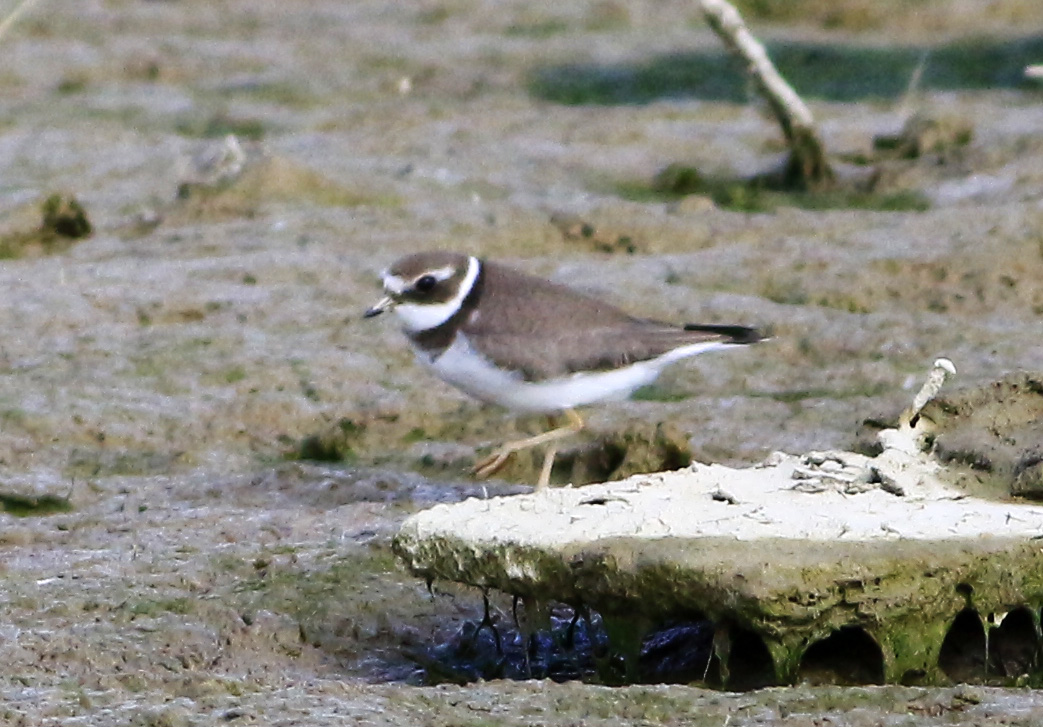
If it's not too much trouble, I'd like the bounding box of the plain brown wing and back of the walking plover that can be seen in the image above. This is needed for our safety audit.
[461,263,749,381]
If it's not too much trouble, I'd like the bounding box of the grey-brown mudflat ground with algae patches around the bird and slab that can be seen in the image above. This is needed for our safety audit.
[0,0,1043,725]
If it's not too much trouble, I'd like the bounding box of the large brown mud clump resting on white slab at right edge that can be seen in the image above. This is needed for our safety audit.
[920,372,1043,500]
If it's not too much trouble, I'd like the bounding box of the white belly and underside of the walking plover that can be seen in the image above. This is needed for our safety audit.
[418,336,727,413]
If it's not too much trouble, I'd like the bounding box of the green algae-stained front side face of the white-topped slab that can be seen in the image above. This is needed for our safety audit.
[395,527,1043,683]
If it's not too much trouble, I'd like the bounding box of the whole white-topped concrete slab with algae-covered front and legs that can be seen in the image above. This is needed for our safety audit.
[394,428,1043,684]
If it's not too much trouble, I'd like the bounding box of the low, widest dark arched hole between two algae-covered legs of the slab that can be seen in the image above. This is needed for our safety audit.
[798,626,883,685]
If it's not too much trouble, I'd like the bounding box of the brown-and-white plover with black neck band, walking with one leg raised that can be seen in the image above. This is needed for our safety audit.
[365,251,761,488]
